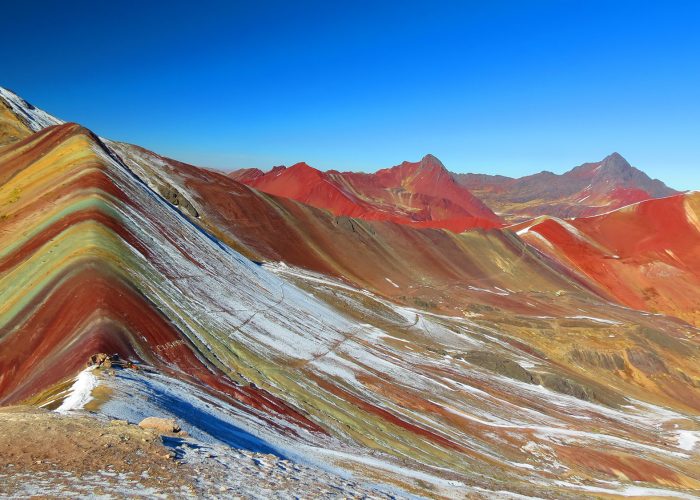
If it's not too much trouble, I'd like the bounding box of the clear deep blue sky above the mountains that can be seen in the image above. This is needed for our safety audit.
[0,0,700,189]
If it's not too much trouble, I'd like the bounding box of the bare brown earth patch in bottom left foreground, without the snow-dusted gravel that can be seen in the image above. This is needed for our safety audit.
[0,406,194,496]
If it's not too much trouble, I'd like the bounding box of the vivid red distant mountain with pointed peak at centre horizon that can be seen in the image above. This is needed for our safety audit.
[230,155,501,232]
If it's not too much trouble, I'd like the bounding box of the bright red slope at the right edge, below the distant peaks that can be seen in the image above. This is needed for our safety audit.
[513,193,700,324]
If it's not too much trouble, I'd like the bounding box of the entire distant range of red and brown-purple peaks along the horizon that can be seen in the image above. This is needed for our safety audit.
[229,153,678,228]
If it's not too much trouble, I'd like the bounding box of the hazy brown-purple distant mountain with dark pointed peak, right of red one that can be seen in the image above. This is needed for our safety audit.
[454,153,678,222]
